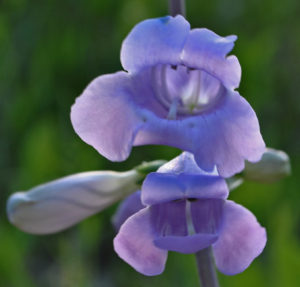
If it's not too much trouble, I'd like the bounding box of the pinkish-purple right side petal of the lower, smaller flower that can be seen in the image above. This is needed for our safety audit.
[213,201,267,275]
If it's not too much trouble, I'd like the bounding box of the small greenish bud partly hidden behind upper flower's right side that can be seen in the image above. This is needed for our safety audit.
[244,148,291,183]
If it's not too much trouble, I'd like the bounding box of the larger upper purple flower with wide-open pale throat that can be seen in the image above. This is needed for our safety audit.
[71,16,265,177]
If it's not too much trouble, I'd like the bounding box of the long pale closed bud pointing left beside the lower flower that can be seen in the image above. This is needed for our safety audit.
[7,170,141,234]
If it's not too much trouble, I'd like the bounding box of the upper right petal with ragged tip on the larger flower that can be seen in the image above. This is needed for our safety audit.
[182,29,241,89]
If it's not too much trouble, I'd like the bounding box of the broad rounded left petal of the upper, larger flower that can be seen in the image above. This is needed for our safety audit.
[71,72,142,161]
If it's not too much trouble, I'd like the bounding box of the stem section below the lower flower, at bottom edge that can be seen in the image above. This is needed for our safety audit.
[195,247,219,287]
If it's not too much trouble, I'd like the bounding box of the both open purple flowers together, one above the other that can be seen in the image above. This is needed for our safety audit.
[71,16,266,275]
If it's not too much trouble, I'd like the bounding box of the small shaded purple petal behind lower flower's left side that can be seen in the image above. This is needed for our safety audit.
[112,190,145,231]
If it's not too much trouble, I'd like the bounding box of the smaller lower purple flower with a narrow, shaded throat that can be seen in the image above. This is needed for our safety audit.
[114,153,266,275]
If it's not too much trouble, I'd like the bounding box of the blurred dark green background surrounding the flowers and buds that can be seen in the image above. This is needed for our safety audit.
[0,0,300,287]
